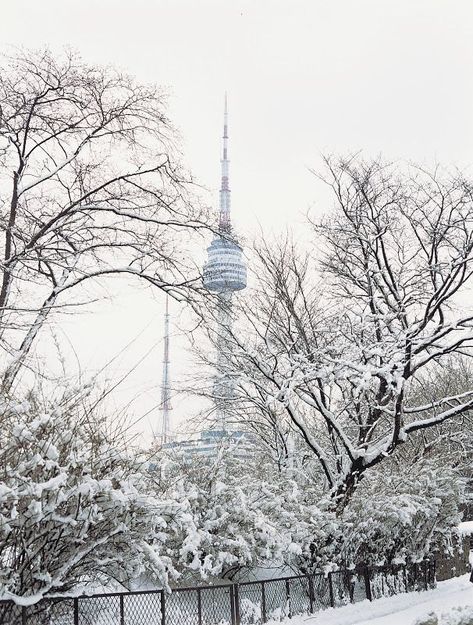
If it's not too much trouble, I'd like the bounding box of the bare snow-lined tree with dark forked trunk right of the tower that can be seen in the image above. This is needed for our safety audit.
[216,159,473,508]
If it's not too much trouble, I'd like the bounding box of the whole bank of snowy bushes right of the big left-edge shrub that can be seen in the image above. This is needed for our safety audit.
[148,442,465,579]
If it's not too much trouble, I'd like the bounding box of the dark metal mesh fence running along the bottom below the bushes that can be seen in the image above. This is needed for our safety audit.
[0,561,435,625]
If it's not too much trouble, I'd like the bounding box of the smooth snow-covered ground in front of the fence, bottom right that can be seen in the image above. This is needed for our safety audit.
[272,575,473,625]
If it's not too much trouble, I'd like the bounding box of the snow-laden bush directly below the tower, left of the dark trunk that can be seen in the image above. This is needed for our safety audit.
[149,450,308,579]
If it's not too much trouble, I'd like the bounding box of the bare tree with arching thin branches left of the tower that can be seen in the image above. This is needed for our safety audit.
[0,51,203,389]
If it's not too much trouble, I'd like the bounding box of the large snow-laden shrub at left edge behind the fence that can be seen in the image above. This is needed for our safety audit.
[0,390,178,601]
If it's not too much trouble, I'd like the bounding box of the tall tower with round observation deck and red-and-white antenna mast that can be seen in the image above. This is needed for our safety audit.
[203,94,246,432]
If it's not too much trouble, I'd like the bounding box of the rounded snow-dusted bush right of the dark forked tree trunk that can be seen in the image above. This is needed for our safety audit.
[340,461,465,565]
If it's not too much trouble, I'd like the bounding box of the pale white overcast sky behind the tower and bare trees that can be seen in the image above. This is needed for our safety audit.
[0,0,473,436]
